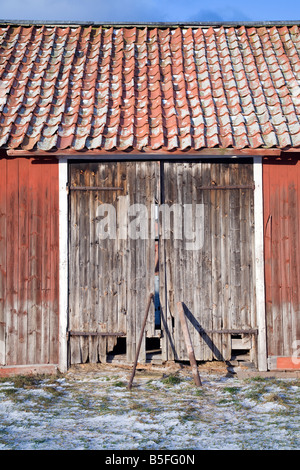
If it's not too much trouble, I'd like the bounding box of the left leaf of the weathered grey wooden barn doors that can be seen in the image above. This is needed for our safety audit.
[69,162,159,364]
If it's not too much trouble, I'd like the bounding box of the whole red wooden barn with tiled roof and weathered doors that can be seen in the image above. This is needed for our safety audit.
[0,21,300,375]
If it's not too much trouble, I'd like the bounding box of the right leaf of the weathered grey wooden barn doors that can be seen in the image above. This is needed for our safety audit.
[160,161,256,360]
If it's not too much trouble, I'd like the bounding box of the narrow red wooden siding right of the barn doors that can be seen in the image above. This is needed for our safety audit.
[263,155,300,368]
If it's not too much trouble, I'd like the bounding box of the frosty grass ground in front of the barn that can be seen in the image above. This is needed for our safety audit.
[0,366,300,450]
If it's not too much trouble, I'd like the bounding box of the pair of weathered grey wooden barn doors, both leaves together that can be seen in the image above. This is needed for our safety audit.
[69,160,256,363]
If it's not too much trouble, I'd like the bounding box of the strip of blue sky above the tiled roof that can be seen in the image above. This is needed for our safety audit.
[0,0,300,23]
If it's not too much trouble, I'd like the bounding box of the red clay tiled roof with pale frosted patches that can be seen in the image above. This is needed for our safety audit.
[0,25,300,151]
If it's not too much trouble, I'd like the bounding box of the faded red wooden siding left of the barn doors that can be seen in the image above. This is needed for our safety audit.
[0,158,59,366]
